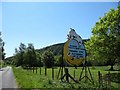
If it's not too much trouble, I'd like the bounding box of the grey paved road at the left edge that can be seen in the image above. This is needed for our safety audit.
[0,66,17,90]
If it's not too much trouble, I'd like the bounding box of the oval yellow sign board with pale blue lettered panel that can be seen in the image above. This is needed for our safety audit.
[64,28,85,66]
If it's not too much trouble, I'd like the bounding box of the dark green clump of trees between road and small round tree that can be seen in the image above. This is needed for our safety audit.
[14,43,37,67]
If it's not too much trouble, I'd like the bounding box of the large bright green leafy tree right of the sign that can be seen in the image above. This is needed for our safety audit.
[85,6,120,70]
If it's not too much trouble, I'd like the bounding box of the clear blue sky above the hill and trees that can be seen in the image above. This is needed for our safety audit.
[0,2,118,57]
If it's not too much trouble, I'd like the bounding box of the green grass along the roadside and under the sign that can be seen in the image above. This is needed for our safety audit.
[13,66,118,89]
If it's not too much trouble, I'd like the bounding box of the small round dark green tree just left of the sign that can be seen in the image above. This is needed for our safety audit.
[42,51,54,68]
